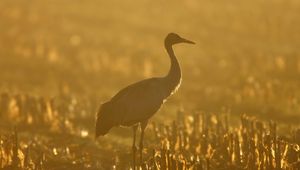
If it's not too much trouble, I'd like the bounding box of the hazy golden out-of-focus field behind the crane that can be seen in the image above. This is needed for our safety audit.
[0,0,300,169]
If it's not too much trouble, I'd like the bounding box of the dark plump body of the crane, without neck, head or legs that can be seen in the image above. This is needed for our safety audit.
[97,77,180,134]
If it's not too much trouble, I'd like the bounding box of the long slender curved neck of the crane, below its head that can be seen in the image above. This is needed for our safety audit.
[165,42,181,92]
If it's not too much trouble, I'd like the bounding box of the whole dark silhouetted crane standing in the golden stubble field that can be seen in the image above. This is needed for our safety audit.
[95,33,195,167]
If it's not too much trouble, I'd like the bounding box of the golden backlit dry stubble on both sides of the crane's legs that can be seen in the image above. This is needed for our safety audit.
[0,94,300,170]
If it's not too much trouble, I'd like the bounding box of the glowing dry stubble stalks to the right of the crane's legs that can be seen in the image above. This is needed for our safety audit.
[143,113,300,169]
